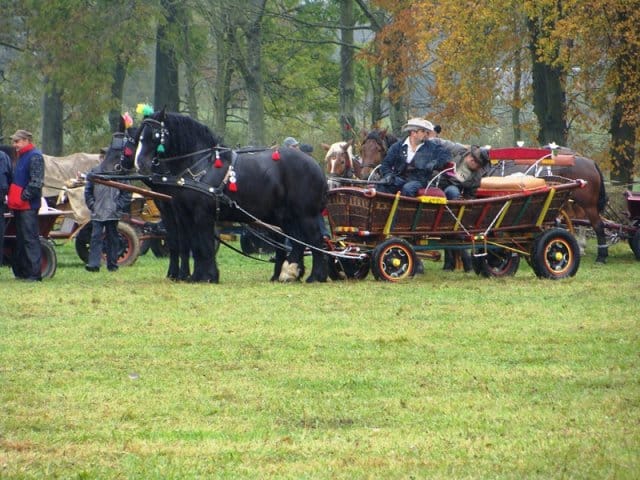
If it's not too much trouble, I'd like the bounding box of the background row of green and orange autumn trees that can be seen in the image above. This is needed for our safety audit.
[0,0,640,183]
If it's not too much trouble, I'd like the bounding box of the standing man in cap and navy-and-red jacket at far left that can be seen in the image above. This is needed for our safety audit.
[7,130,44,281]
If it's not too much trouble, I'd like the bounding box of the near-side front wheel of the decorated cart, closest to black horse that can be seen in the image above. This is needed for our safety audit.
[371,238,417,282]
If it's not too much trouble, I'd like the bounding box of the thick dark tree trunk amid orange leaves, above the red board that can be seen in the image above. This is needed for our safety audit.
[527,15,567,145]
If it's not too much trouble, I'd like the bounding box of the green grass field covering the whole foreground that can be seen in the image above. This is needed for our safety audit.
[0,239,640,479]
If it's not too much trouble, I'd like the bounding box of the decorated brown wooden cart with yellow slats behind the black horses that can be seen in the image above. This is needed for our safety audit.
[327,177,584,281]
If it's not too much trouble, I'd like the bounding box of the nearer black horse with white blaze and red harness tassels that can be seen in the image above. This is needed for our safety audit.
[127,110,327,283]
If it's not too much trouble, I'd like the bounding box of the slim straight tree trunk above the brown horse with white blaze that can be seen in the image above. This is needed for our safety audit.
[340,0,356,140]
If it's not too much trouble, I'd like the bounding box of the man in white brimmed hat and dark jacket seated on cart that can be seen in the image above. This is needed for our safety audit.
[378,118,450,197]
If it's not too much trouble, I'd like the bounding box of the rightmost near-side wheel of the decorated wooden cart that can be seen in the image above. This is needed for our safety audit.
[531,228,580,280]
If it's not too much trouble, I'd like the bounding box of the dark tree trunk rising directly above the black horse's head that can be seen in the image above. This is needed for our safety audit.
[153,0,180,112]
